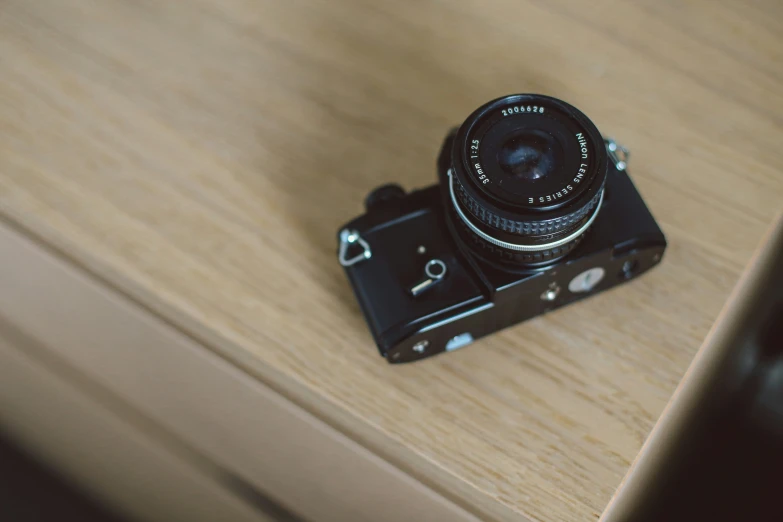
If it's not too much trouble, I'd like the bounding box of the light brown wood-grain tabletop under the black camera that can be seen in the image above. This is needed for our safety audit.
[0,0,783,521]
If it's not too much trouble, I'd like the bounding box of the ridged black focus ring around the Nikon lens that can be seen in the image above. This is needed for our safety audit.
[454,179,601,236]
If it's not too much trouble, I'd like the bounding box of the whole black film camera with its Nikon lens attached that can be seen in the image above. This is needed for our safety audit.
[338,94,666,363]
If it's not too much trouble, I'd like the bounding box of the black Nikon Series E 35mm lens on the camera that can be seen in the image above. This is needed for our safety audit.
[448,94,607,266]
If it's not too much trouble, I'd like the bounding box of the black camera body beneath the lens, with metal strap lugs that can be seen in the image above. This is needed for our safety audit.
[338,94,666,363]
